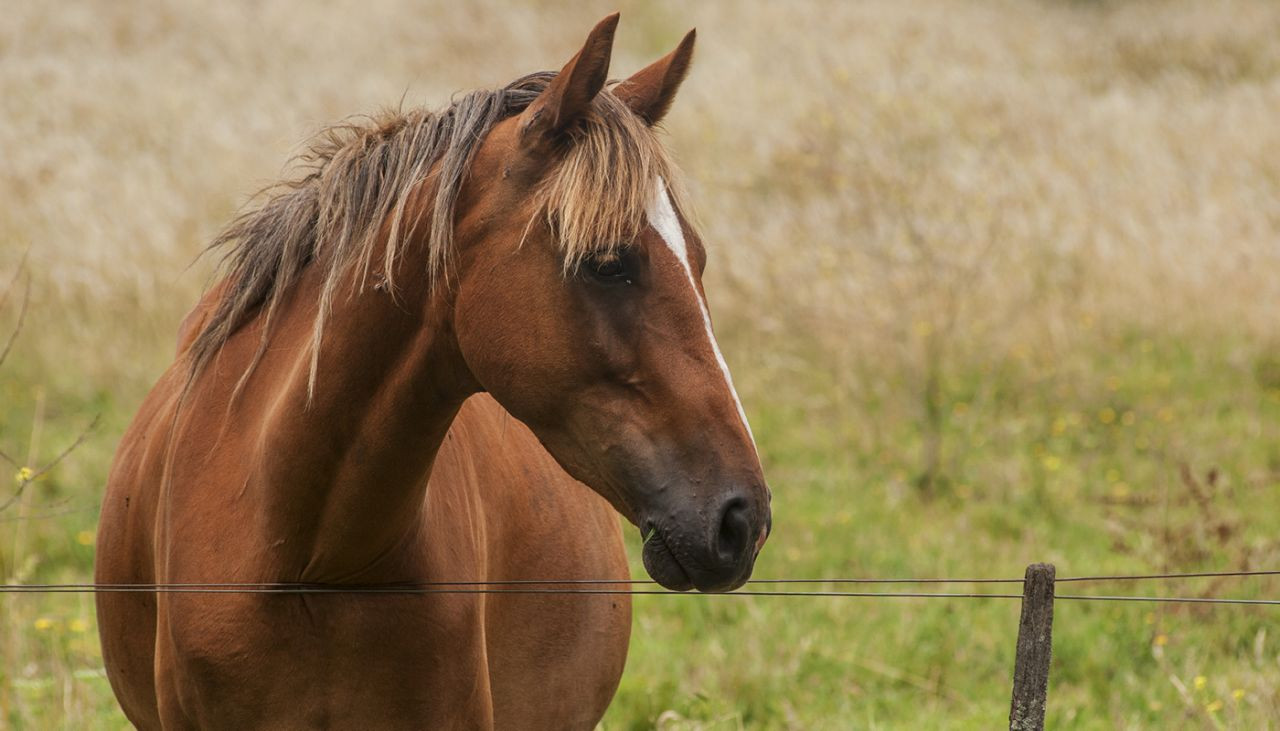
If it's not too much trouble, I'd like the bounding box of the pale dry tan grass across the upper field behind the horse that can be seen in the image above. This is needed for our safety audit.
[0,1,1280,412]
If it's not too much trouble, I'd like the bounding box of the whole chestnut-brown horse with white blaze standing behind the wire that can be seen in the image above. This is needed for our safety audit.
[96,15,769,728]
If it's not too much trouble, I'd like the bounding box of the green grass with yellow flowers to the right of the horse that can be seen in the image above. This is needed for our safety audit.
[605,327,1280,728]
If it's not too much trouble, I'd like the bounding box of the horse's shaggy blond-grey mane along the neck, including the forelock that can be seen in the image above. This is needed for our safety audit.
[187,72,682,388]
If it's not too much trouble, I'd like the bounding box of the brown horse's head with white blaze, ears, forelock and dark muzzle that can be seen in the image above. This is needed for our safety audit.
[449,15,771,591]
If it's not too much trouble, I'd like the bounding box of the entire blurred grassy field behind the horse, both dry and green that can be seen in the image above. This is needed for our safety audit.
[0,0,1280,728]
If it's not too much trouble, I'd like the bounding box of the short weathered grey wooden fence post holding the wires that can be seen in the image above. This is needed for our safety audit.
[1009,563,1055,731]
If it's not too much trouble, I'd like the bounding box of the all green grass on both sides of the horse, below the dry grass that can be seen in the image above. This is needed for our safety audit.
[0,322,1280,728]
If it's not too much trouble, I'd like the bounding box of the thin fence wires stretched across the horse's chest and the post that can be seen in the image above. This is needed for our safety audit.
[0,570,1280,606]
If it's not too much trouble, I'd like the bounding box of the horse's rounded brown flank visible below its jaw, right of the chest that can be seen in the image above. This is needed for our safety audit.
[426,394,631,728]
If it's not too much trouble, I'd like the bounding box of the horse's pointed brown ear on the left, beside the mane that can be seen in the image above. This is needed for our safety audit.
[520,13,618,145]
